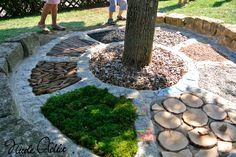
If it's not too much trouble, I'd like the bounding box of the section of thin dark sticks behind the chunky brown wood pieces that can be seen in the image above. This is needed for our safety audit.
[47,36,96,57]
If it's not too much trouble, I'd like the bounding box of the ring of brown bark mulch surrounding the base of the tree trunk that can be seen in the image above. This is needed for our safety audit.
[90,45,187,90]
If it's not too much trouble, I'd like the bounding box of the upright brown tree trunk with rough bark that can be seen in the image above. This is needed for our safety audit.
[122,0,158,68]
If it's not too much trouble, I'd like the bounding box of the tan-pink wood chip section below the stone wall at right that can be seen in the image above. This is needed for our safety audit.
[181,42,228,62]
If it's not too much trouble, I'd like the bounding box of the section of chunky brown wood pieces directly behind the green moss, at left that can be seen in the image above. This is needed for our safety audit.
[29,61,81,95]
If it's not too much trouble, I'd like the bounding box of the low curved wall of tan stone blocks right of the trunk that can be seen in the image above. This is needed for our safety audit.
[156,13,236,53]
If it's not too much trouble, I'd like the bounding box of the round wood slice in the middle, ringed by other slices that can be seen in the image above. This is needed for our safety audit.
[183,109,208,127]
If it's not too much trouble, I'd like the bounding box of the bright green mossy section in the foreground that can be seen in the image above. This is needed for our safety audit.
[42,86,137,157]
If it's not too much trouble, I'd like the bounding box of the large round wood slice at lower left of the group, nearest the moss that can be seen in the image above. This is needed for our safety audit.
[157,131,188,151]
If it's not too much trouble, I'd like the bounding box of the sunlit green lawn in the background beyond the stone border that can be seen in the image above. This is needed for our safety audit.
[0,0,236,42]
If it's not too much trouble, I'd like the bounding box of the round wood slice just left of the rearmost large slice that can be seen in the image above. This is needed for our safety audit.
[163,98,186,114]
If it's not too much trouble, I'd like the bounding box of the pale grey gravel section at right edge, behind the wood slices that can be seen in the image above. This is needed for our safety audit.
[198,64,236,102]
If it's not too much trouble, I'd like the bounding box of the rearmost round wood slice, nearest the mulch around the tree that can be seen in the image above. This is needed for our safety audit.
[180,93,204,108]
